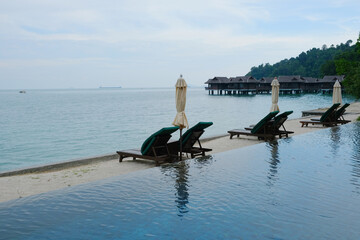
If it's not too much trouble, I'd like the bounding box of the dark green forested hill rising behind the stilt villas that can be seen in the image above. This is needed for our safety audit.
[246,34,360,97]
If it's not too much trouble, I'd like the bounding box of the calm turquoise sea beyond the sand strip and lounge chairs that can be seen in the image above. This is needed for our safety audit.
[0,88,353,172]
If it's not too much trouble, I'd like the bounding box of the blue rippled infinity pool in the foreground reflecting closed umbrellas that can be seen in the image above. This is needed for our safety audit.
[0,123,360,239]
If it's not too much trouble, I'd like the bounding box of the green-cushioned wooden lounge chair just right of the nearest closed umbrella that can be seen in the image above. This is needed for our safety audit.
[169,122,213,158]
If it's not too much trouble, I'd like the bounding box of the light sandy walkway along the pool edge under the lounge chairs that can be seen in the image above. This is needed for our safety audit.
[0,102,360,202]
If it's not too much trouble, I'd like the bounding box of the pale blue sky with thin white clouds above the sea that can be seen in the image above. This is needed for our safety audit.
[0,0,360,89]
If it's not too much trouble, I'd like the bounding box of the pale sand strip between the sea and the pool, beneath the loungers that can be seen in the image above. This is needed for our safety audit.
[0,102,360,202]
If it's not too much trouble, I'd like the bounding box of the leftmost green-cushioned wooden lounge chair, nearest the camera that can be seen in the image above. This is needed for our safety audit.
[117,127,179,165]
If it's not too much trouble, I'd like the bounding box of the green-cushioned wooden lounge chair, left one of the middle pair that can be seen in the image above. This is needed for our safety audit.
[228,111,279,140]
